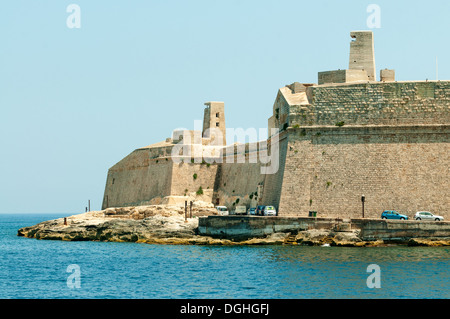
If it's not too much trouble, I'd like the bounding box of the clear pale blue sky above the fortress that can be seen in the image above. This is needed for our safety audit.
[0,0,450,214]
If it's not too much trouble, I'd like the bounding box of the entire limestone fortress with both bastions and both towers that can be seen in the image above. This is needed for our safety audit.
[102,31,450,219]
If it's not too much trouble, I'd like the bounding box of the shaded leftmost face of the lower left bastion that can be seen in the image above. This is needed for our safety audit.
[102,149,172,209]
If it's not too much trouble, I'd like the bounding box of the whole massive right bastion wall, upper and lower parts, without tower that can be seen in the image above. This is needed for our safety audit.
[263,81,450,218]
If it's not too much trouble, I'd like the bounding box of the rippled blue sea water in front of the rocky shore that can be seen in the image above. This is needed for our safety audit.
[0,214,450,299]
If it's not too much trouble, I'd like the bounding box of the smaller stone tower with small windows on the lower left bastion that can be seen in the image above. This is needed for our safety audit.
[203,102,226,145]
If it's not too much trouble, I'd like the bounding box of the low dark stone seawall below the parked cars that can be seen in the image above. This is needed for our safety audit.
[198,216,450,242]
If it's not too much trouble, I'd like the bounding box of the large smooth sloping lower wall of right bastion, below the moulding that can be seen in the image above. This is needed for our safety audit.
[280,125,450,219]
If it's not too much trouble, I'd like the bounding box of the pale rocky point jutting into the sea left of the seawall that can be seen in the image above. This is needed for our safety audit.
[18,205,216,242]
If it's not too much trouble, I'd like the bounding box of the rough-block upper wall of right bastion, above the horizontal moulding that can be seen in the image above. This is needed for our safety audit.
[289,81,450,127]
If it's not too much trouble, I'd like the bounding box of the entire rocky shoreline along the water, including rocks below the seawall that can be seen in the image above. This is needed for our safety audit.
[18,203,450,247]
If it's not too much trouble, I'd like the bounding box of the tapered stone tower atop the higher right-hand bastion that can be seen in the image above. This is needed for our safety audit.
[349,31,376,81]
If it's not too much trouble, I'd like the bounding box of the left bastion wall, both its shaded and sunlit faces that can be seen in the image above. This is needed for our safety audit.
[102,146,218,209]
